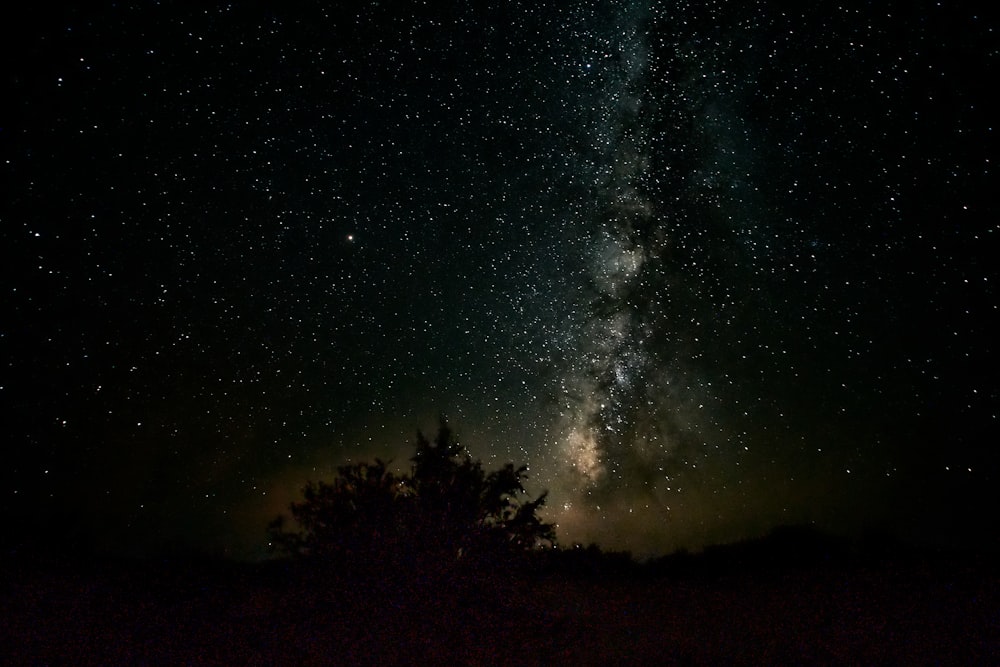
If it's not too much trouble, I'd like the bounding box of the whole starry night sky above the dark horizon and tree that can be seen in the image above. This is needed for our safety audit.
[0,0,1000,557]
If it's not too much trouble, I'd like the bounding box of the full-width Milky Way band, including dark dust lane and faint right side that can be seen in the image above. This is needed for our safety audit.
[559,6,754,544]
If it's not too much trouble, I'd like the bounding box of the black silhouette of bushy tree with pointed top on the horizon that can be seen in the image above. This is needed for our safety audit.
[270,418,555,562]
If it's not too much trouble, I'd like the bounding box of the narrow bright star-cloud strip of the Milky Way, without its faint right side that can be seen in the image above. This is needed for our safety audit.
[560,1,670,506]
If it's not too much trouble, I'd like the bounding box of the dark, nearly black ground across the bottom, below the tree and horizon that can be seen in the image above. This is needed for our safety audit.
[0,544,1000,665]
